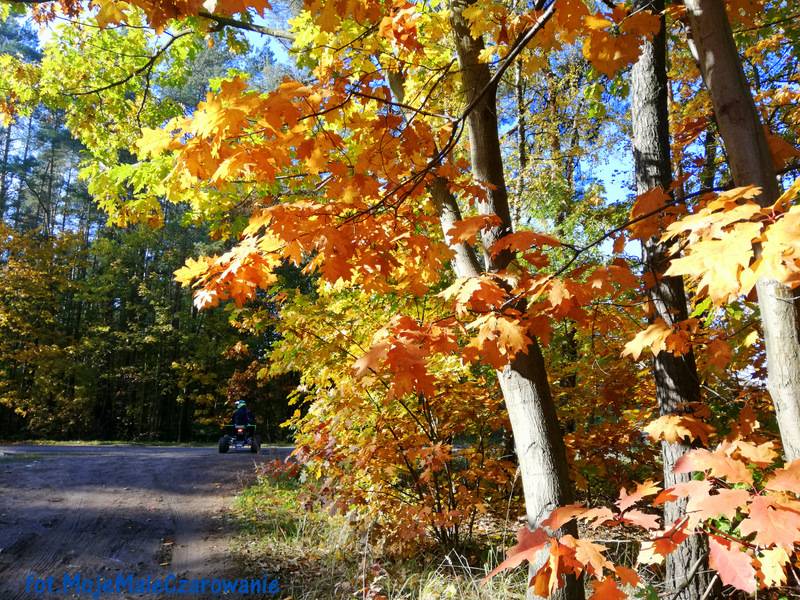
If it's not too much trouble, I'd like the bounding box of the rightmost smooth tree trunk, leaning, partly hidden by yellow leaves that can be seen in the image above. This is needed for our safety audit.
[685,0,800,460]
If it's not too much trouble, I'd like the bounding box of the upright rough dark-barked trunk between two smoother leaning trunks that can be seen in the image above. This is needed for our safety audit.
[631,0,711,600]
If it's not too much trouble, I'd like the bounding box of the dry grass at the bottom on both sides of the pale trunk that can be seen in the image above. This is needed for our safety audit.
[228,461,663,600]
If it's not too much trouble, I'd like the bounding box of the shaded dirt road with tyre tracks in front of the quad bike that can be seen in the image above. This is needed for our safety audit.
[0,446,289,600]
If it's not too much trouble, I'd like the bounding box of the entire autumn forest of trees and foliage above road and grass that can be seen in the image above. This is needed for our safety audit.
[0,0,800,600]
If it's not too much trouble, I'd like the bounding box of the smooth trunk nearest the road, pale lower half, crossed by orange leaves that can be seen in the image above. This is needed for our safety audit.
[450,0,583,600]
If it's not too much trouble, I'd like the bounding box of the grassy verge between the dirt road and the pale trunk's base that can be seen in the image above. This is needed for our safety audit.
[233,477,526,600]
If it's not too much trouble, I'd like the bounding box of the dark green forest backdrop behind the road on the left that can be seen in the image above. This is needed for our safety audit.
[0,20,296,441]
